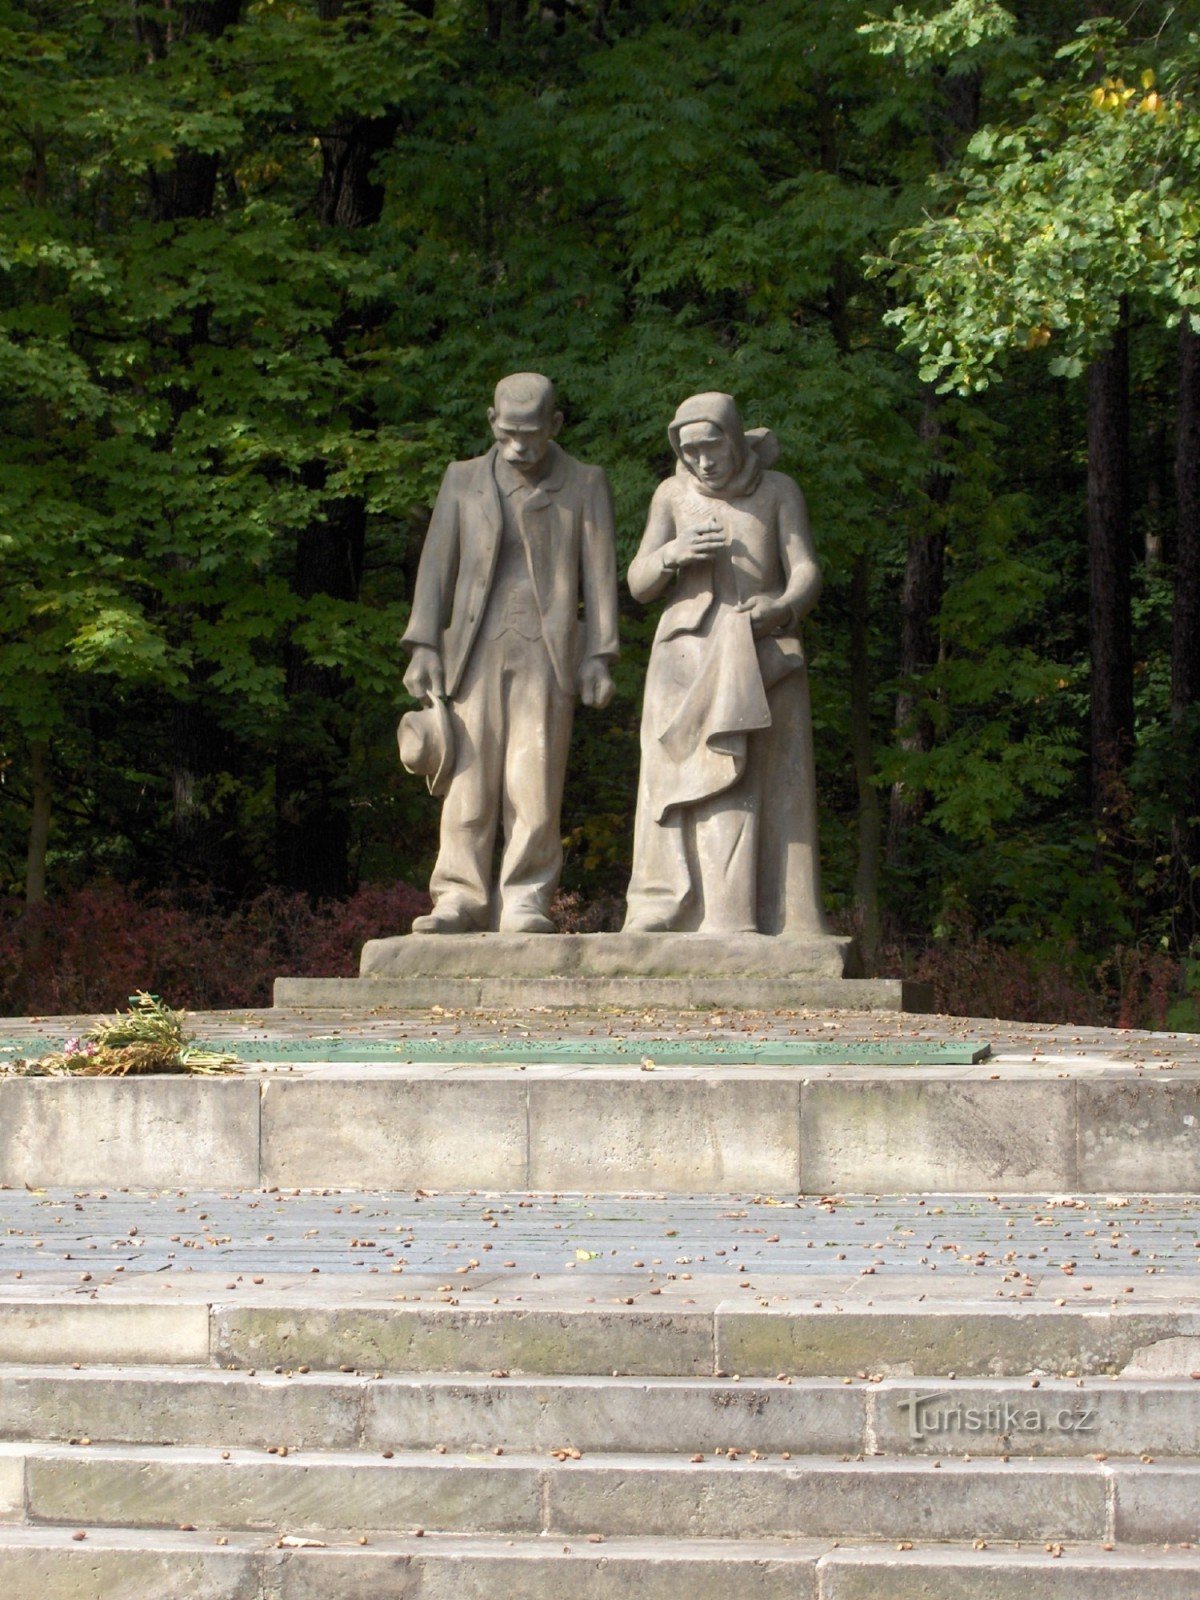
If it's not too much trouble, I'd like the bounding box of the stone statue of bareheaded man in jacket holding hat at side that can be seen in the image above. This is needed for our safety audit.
[402,373,618,933]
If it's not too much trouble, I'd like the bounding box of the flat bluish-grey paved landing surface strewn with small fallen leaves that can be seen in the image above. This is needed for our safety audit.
[0,1189,1200,1298]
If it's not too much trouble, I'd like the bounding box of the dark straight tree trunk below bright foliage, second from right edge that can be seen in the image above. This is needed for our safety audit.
[1088,318,1133,846]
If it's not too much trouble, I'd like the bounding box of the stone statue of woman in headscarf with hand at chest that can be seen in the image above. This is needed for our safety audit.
[626,394,829,938]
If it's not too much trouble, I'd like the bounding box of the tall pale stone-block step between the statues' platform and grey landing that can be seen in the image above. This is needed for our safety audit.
[0,1045,1200,1197]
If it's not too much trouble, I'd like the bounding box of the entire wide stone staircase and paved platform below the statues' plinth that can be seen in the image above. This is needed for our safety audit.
[0,1013,1200,1600]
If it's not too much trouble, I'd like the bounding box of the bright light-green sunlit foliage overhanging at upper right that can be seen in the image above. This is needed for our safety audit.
[866,0,1200,394]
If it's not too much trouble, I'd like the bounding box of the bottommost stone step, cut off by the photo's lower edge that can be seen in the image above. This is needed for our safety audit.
[0,1526,1200,1600]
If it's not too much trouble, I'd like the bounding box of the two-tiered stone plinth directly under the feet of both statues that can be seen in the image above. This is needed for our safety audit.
[275,933,933,1011]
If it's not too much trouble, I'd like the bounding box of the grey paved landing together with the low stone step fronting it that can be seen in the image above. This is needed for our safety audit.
[0,1190,1200,1376]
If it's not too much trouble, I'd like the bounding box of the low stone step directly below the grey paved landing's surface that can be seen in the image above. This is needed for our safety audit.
[0,1275,1200,1378]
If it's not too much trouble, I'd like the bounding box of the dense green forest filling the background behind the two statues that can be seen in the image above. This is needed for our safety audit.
[0,0,1200,1026]
